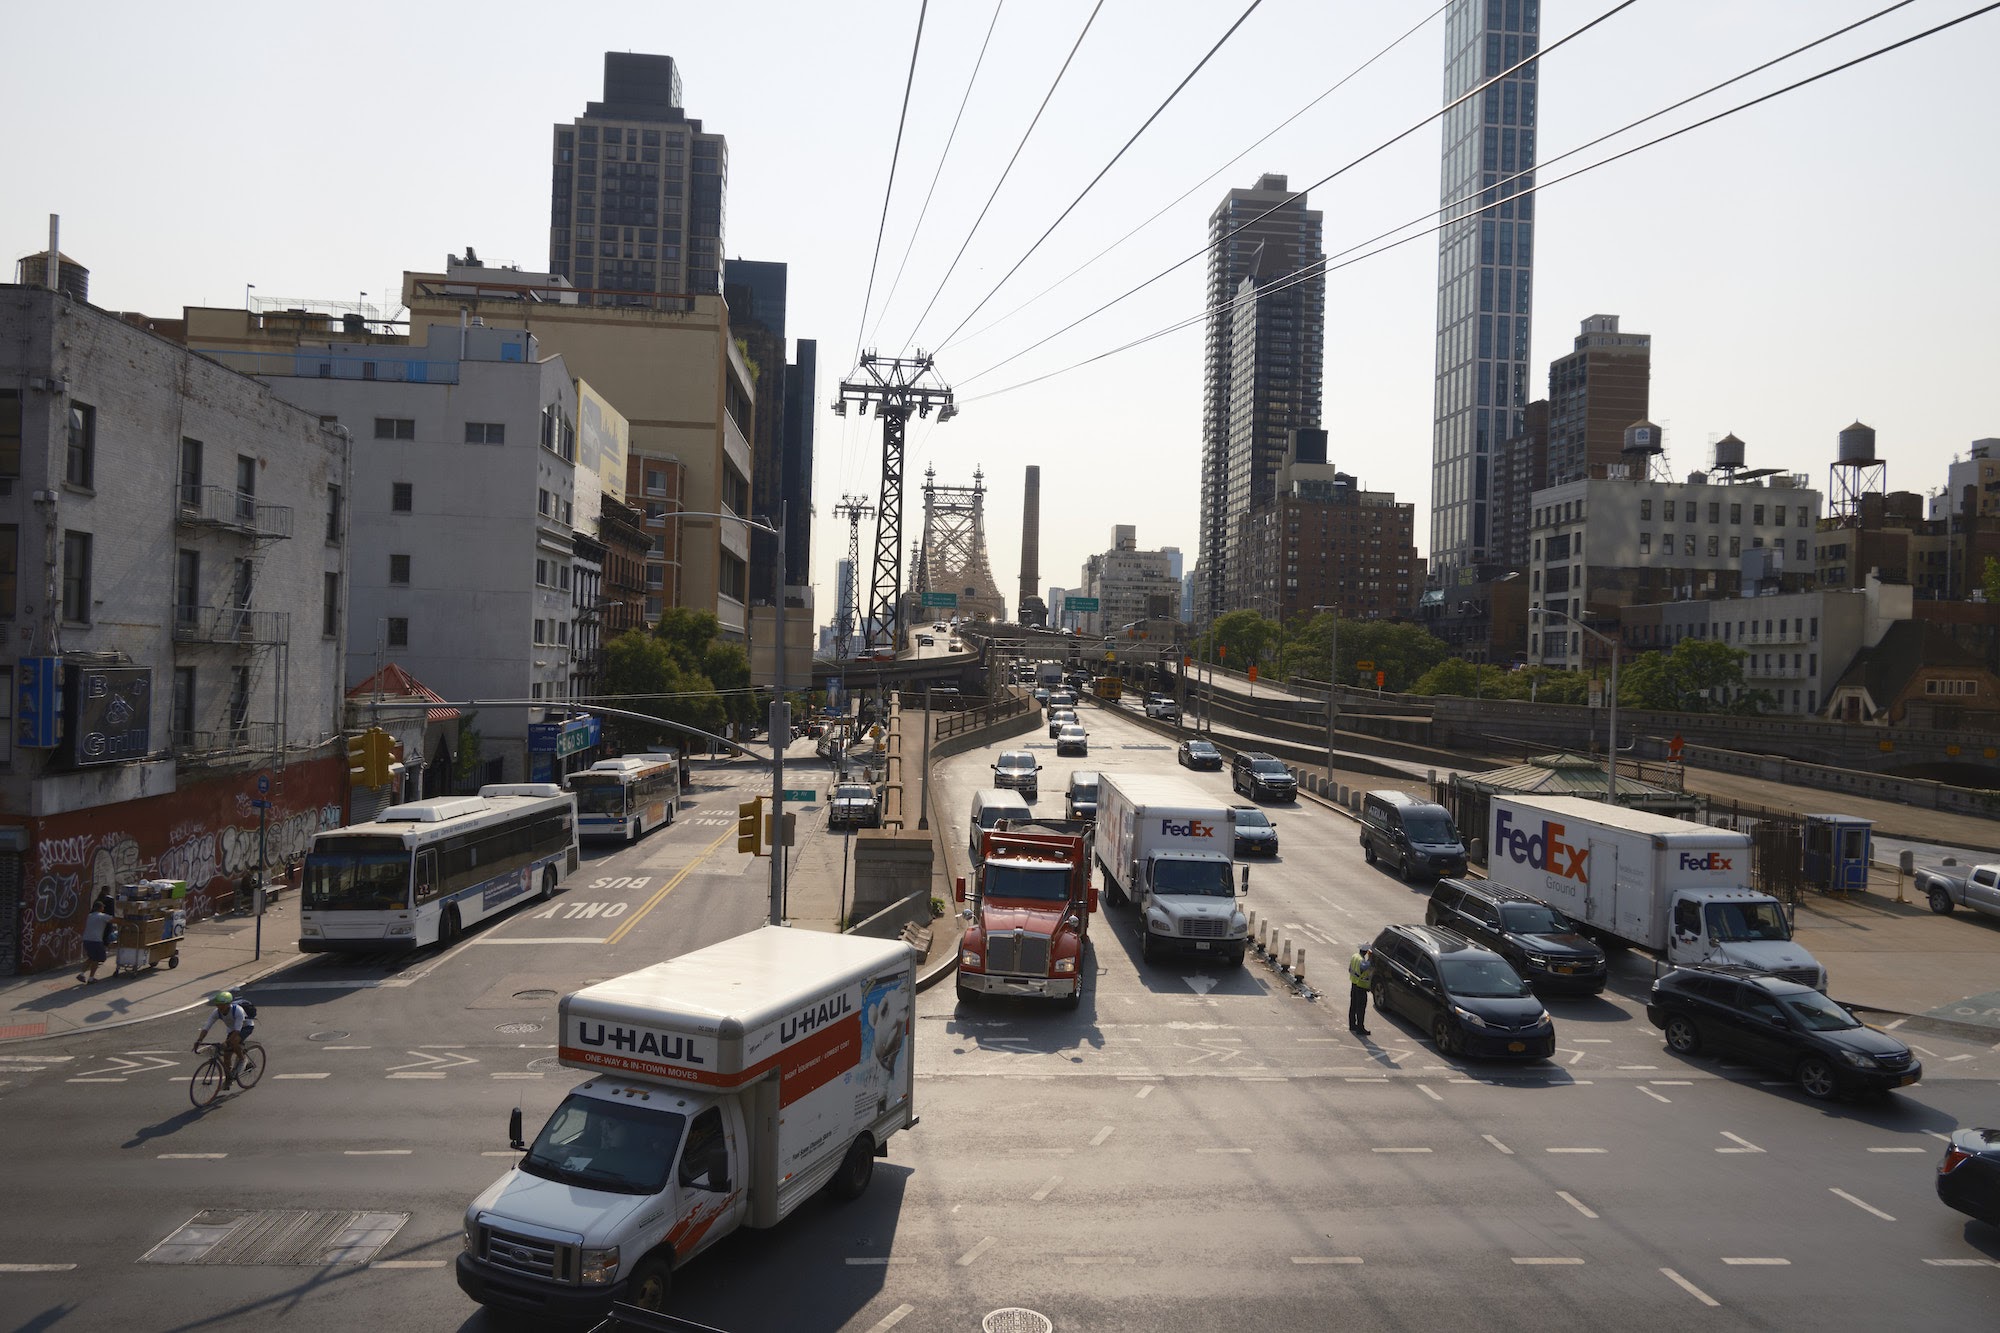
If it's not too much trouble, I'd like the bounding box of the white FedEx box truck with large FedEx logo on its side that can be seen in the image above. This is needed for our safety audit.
[1486,795,1826,991]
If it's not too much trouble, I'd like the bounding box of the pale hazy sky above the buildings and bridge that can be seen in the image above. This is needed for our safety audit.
[0,0,2000,620]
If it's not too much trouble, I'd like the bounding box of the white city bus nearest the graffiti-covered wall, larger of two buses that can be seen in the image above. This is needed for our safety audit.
[298,783,578,953]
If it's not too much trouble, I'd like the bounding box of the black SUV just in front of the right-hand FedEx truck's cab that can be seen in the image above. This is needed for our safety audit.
[1646,967,1924,1099]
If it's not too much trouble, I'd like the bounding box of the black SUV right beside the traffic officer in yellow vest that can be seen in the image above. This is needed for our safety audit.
[1372,925,1556,1061]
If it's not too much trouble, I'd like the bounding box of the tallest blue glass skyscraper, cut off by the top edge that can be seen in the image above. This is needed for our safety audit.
[1430,0,1542,584]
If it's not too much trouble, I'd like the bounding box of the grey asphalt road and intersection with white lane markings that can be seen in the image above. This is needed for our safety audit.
[0,709,2000,1333]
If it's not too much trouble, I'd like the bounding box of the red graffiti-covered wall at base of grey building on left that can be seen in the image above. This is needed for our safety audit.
[16,757,348,973]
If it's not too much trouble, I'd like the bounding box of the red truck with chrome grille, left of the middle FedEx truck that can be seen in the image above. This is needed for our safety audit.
[958,827,1098,1009]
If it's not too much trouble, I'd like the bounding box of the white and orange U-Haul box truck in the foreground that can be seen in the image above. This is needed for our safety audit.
[458,927,916,1319]
